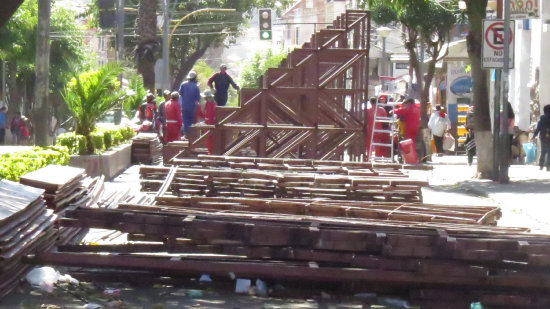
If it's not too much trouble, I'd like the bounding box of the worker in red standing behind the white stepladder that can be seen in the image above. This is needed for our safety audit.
[366,97,391,160]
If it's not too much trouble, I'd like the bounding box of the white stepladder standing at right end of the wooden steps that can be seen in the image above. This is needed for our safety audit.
[368,100,397,162]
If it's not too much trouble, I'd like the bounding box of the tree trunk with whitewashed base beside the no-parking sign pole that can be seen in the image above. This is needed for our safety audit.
[466,0,493,179]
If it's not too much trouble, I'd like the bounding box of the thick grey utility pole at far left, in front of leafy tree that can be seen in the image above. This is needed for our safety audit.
[32,0,51,146]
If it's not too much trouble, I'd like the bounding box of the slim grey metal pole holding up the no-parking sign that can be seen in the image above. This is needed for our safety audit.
[498,0,511,183]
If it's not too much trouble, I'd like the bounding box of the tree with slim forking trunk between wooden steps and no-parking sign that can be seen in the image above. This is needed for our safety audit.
[367,0,456,157]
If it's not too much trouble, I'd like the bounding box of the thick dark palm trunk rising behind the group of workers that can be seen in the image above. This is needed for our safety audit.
[134,0,160,93]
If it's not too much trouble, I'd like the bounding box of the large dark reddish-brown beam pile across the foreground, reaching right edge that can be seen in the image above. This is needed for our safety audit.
[37,205,550,308]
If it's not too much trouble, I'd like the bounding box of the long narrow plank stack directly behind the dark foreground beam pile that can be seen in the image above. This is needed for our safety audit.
[155,196,502,225]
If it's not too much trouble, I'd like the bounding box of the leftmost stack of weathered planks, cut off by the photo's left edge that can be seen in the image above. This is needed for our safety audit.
[0,180,56,297]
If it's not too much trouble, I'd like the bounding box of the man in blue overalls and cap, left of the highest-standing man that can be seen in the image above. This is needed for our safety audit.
[179,71,201,136]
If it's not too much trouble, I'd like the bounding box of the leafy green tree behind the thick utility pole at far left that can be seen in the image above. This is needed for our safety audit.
[0,0,94,139]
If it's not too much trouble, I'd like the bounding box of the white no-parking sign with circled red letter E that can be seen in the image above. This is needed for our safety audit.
[481,19,515,69]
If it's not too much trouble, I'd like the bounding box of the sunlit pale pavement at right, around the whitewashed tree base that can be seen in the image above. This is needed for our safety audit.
[410,155,550,234]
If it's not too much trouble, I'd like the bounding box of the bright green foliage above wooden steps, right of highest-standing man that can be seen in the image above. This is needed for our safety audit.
[239,49,288,88]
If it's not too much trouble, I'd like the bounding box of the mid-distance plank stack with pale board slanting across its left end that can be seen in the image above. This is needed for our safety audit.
[140,166,428,202]
